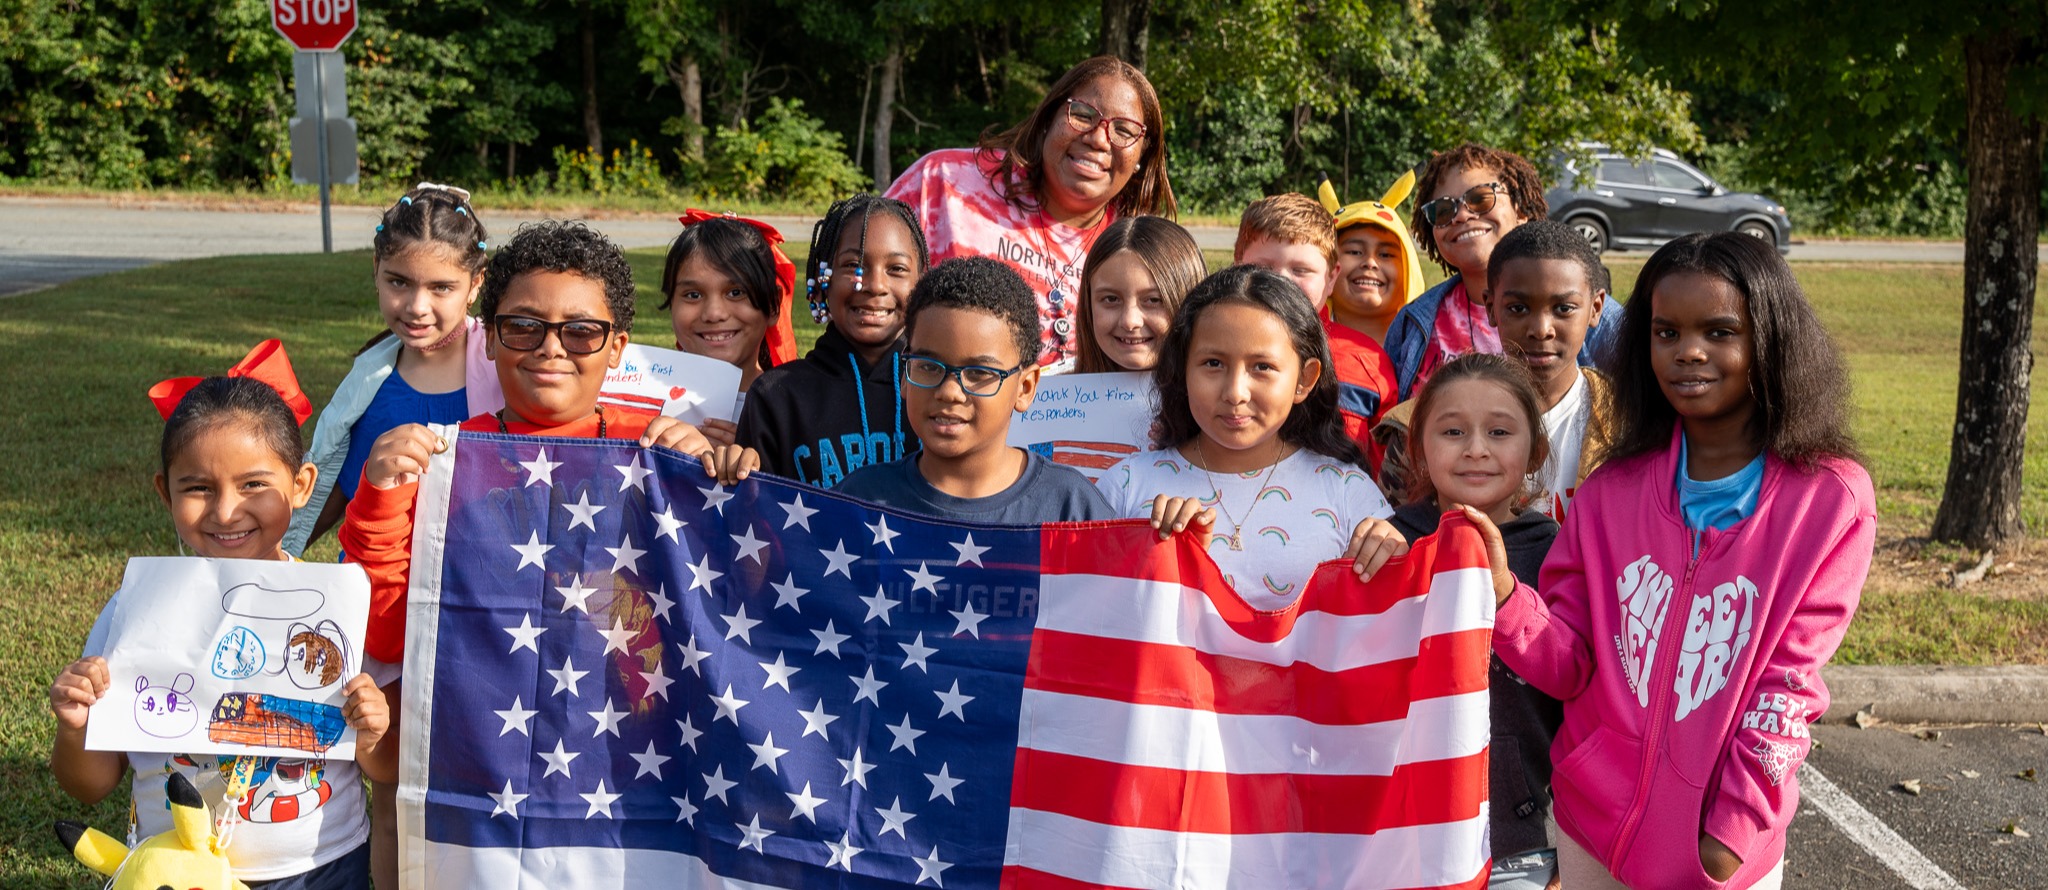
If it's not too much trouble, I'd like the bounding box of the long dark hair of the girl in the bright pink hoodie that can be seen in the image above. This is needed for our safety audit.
[1608,231,1860,469]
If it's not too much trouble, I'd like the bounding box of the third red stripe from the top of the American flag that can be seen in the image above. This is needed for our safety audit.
[1010,749,1487,835]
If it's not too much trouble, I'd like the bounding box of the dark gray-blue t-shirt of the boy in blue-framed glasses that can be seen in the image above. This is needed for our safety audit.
[831,450,1116,526]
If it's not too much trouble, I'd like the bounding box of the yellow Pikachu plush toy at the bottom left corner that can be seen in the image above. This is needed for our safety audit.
[57,773,248,890]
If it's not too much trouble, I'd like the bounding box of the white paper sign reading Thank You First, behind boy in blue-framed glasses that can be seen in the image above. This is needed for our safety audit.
[1010,370,1155,481]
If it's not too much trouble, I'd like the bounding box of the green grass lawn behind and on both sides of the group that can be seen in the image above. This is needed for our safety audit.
[0,246,2048,888]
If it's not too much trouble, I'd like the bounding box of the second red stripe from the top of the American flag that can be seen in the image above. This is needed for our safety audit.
[1024,628,1493,726]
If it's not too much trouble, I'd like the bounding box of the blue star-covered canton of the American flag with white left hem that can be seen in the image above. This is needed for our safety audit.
[406,434,1040,888]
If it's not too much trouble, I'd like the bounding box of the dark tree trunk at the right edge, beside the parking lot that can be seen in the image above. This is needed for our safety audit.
[1933,29,2042,548]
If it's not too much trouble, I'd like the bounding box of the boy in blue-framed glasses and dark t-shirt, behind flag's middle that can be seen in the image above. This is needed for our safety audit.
[834,258,1116,526]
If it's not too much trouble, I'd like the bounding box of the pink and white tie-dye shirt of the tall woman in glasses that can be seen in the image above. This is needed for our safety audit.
[887,149,1116,364]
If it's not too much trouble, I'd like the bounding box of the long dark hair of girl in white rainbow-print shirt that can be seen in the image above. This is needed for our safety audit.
[1153,264,1362,464]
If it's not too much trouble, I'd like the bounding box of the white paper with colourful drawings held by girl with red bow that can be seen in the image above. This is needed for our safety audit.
[86,557,371,759]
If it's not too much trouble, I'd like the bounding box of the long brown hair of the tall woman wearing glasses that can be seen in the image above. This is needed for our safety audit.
[981,55,1180,217]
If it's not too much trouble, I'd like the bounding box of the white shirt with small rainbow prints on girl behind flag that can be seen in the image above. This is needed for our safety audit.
[1096,448,1395,610]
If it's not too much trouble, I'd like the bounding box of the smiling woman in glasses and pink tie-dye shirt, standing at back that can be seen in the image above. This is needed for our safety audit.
[887,55,1176,364]
